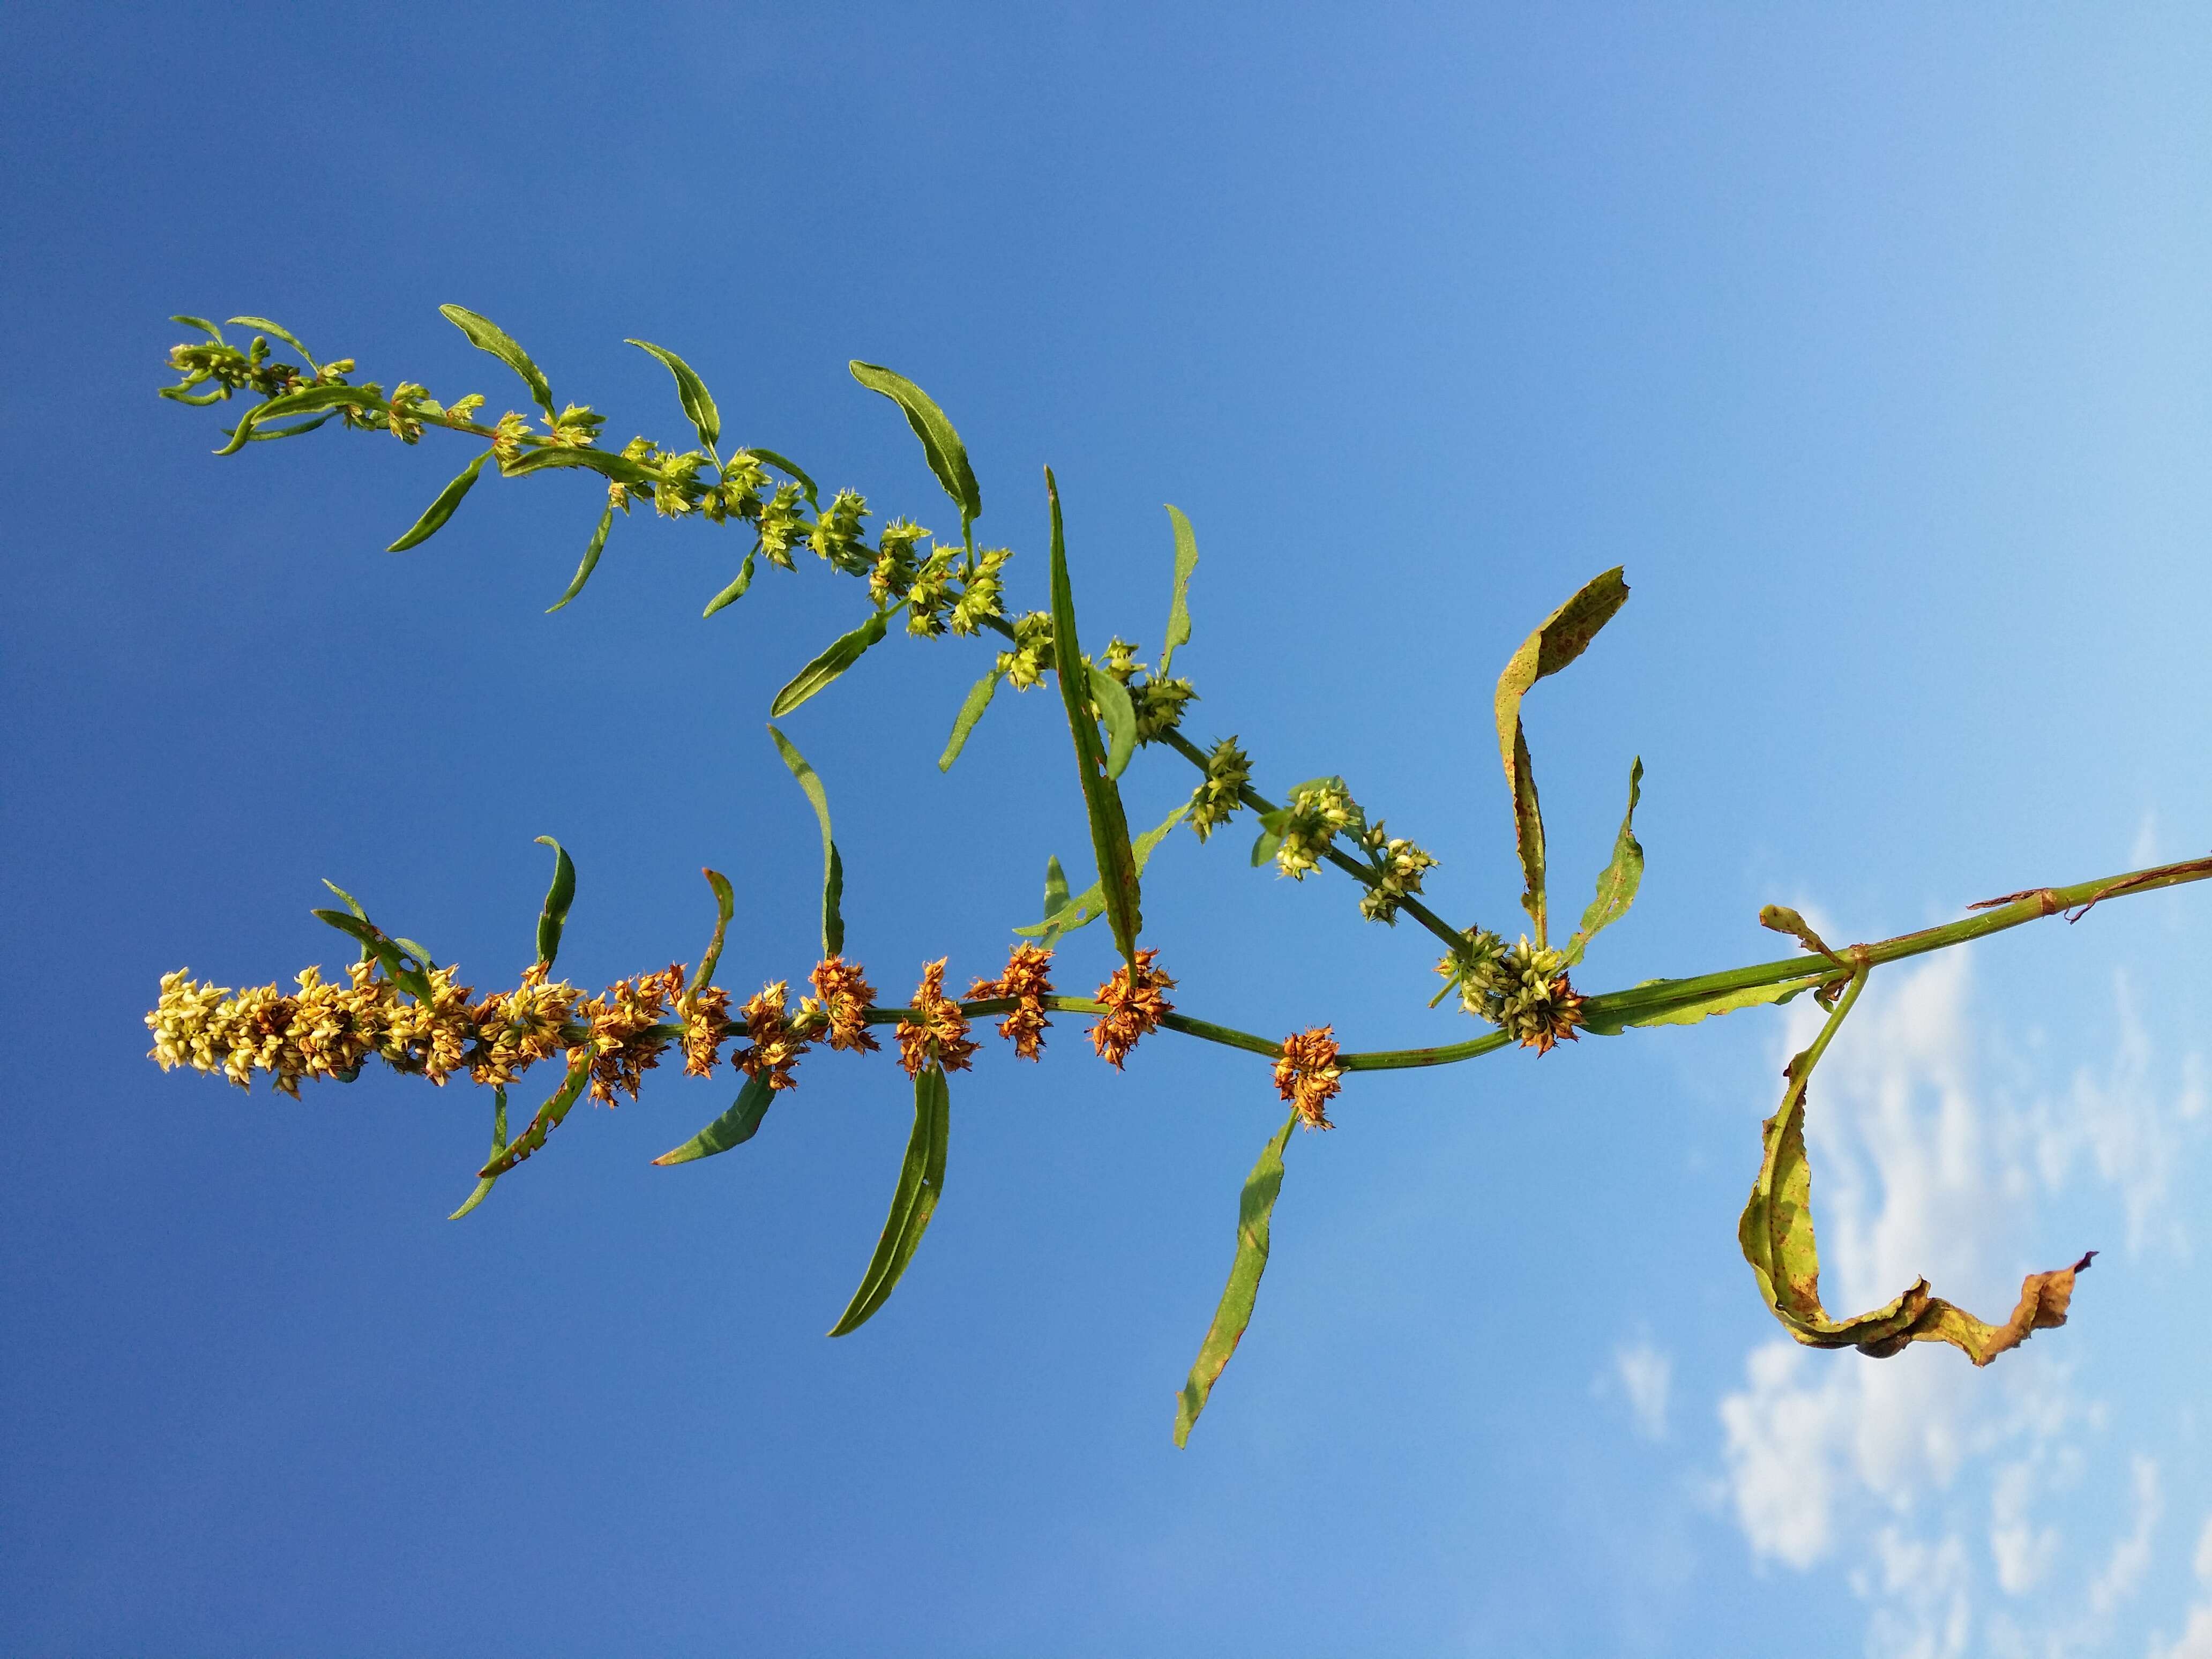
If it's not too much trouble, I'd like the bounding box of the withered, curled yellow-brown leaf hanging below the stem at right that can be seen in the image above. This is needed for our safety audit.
[1736,969,2097,1365]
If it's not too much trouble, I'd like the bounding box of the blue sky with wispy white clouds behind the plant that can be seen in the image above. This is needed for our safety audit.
[0,0,2212,1659]
